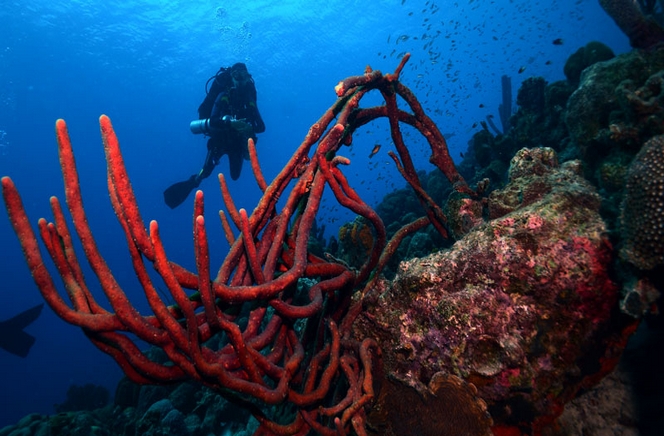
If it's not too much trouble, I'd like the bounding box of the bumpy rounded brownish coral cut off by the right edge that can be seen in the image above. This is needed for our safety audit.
[620,135,664,270]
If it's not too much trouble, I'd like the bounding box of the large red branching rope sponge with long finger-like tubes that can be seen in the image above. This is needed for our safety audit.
[2,55,477,436]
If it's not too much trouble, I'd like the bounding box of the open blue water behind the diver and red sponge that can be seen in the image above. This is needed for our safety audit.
[0,0,629,428]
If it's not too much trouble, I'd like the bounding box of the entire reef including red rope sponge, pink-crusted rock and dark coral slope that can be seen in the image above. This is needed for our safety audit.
[6,5,664,430]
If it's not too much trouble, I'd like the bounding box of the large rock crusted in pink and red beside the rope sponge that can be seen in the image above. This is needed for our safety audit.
[355,148,617,431]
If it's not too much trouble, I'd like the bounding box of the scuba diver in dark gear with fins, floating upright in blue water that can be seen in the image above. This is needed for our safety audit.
[164,63,265,209]
